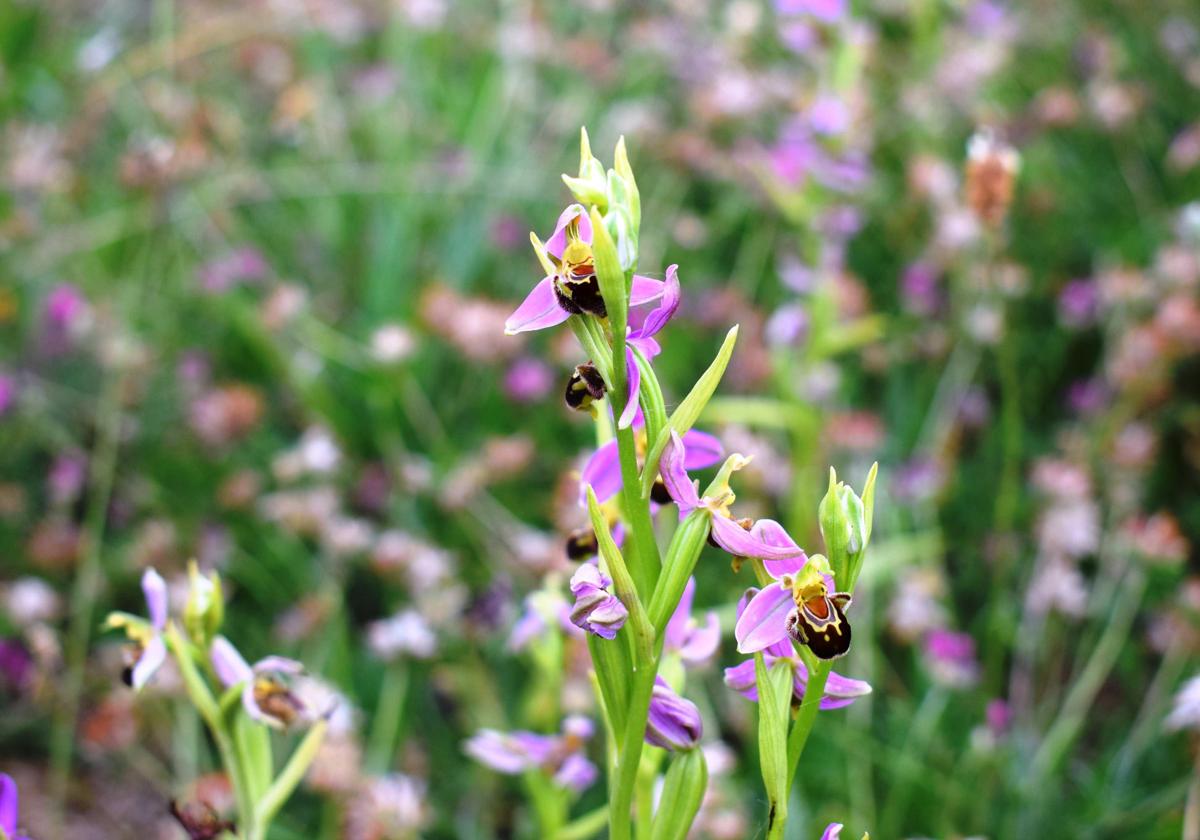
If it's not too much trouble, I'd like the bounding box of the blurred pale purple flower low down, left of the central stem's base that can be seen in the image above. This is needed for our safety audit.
[463,715,598,793]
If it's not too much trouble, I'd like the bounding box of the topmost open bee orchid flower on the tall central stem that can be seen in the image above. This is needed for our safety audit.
[504,204,665,335]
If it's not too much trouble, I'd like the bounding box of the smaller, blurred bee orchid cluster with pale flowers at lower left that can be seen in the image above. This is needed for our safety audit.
[103,562,332,840]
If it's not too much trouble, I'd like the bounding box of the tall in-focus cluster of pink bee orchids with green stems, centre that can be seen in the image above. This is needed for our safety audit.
[466,131,875,840]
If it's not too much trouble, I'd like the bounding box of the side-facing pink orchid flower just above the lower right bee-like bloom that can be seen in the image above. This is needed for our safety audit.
[661,430,806,565]
